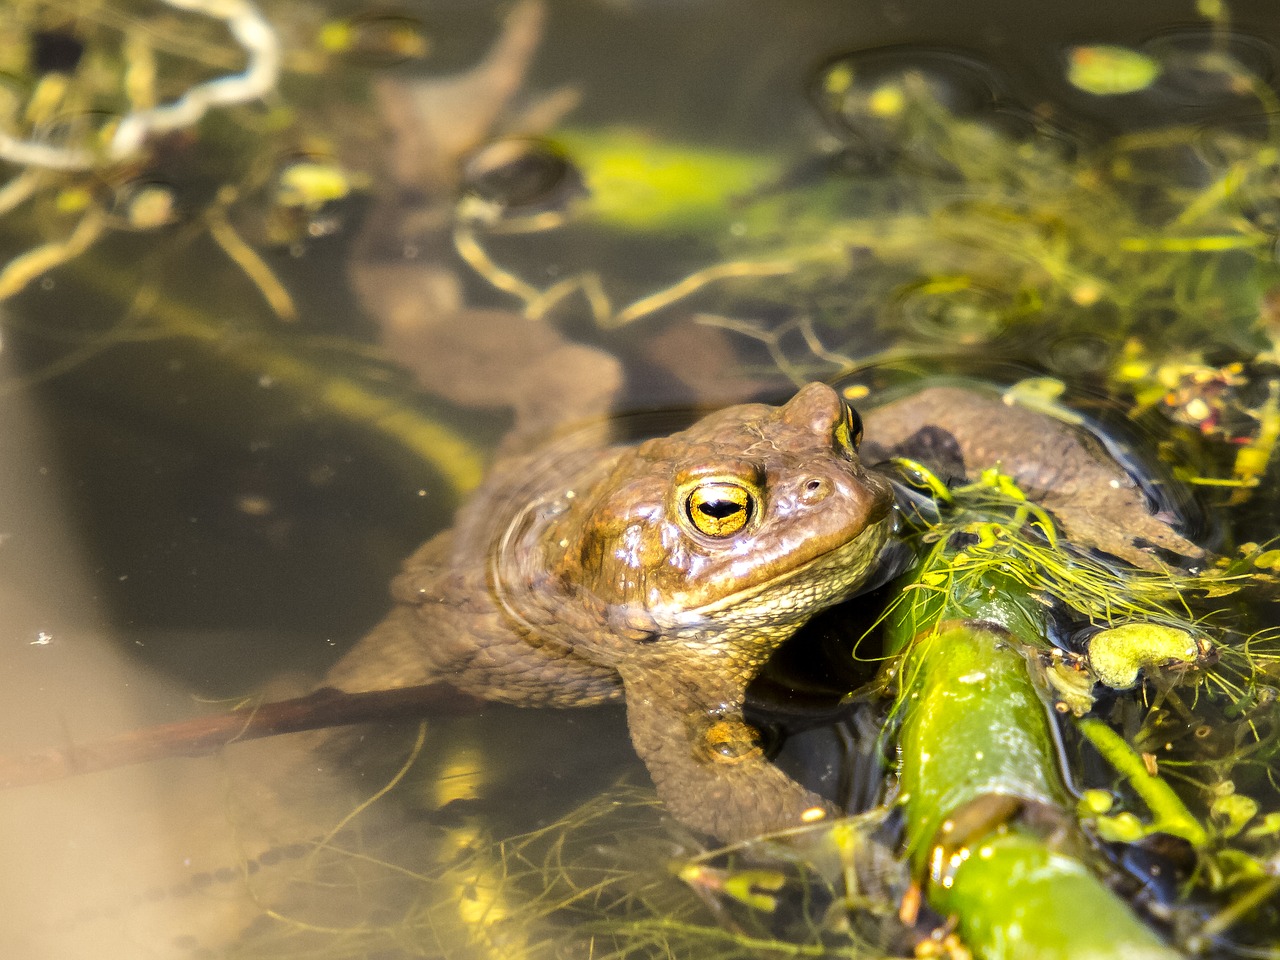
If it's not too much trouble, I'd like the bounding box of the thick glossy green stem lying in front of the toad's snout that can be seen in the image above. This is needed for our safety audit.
[887,570,1178,960]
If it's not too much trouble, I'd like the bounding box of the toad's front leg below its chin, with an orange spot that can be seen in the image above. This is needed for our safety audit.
[622,669,836,841]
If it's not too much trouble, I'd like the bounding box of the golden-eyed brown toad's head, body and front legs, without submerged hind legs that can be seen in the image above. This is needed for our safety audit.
[328,383,1198,840]
